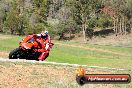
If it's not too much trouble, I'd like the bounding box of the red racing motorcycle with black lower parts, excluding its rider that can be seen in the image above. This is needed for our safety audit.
[9,35,54,60]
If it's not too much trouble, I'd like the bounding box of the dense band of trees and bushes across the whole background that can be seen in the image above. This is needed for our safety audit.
[0,0,132,38]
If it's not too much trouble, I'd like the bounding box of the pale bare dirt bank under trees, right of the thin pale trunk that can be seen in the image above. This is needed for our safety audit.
[88,35,132,46]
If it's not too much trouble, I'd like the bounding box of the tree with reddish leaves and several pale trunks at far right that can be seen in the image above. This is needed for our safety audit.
[103,0,132,35]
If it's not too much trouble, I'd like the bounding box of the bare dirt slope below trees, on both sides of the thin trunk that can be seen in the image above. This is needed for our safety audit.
[75,34,132,46]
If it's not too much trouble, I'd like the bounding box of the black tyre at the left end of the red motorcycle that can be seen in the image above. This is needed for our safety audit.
[9,48,21,59]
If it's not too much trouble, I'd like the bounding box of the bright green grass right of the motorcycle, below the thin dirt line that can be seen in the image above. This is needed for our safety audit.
[47,45,132,68]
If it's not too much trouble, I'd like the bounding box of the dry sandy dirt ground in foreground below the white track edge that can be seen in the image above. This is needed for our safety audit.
[0,62,118,88]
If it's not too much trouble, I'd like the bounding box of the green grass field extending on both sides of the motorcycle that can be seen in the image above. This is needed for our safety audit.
[0,35,132,69]
